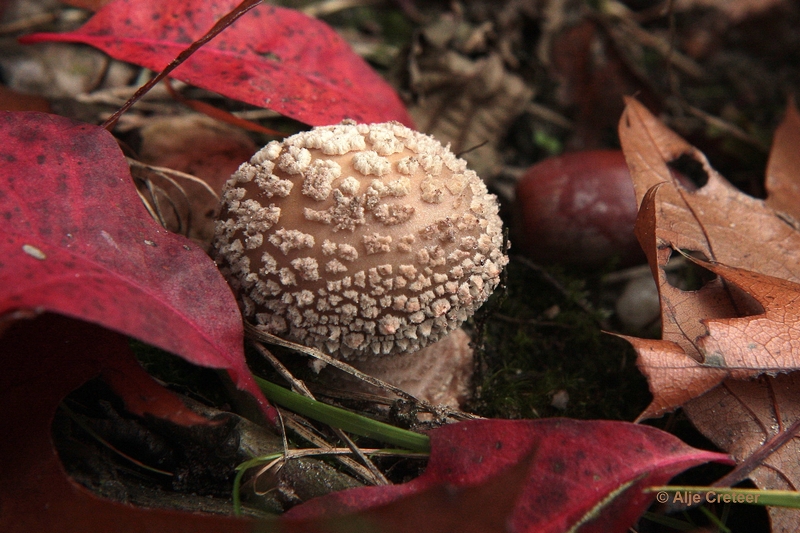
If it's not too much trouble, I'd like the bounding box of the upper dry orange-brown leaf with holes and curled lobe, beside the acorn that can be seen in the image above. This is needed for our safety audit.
[620,100,800,418]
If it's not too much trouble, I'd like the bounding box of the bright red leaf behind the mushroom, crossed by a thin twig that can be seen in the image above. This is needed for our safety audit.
[21,0,412,126]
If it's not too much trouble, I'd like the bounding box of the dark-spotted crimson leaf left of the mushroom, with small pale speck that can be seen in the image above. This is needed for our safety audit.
[0,112,273,424]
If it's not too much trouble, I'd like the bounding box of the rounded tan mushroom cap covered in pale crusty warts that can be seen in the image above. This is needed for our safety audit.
[208,121,508,359]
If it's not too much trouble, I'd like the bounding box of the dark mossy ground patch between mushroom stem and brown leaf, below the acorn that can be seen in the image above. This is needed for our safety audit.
[468,261,650,420]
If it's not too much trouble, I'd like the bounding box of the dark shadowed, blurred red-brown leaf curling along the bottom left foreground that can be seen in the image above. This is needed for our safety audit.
[0,314,524,533]
